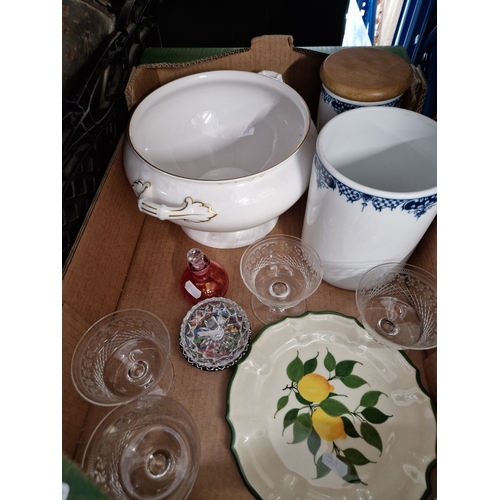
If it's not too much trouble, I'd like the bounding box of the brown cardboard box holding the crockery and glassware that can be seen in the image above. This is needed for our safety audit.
[62,36,437,500]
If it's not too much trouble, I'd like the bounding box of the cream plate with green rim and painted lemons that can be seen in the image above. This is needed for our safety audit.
[226,312,436,500]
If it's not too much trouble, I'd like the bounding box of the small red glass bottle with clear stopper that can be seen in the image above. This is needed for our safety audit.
[180,248,229,304]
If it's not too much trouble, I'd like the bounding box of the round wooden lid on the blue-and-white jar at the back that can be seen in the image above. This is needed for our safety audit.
[320,47,413,102]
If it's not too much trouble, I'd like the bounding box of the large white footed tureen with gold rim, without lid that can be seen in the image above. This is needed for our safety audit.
[123,71,317,248]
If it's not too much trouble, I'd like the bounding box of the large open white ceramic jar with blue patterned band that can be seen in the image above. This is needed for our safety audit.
[302,107,437,290]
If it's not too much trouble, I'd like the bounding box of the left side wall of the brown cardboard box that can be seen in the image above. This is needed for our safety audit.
[62,137,145,457]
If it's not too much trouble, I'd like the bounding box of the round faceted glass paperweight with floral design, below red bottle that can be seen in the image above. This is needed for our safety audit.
[179,297,252,371]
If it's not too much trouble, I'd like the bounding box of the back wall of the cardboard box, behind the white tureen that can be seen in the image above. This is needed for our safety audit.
[125,35,328,119]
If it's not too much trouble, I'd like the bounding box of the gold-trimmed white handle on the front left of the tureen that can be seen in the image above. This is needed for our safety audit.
[132,179,217,222]
